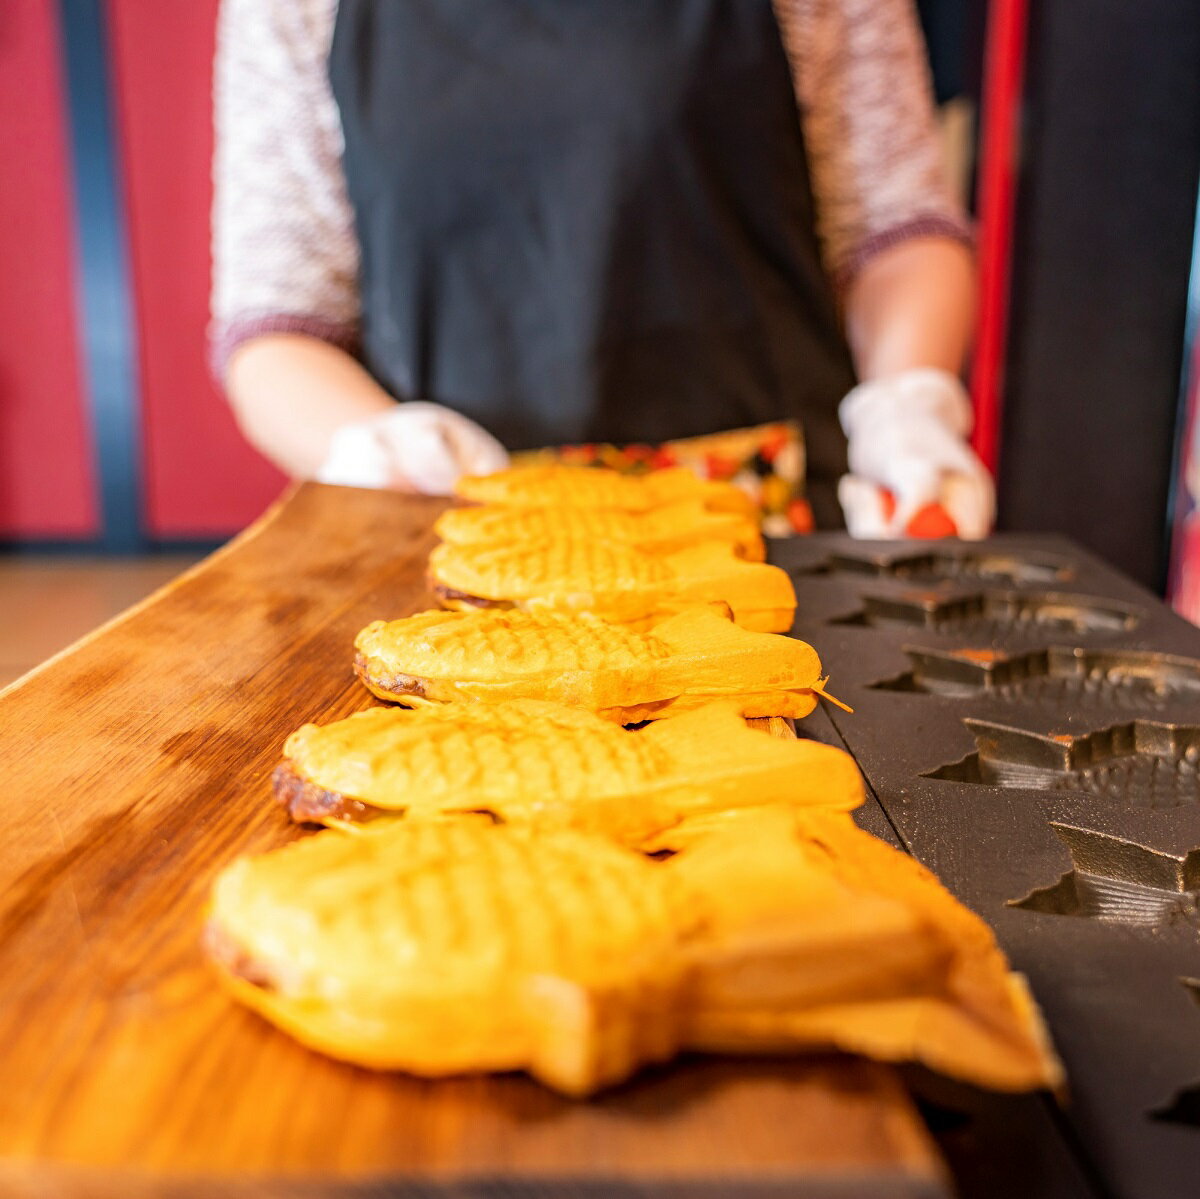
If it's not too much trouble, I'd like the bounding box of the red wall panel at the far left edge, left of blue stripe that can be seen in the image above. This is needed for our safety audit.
[0,0,97,538]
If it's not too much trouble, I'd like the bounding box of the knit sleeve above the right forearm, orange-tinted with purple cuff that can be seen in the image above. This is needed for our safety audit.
[775,0,972,289]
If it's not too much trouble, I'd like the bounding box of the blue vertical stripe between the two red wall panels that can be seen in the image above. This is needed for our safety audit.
[60,0,145,553]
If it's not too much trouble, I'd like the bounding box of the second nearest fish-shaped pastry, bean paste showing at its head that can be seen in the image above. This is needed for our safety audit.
[274,700,863,843]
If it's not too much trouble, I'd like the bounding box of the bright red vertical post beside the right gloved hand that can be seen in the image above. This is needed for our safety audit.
[971,0,1027,473]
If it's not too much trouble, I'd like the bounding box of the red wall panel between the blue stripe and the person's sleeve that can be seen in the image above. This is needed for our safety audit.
[107,0,283,538]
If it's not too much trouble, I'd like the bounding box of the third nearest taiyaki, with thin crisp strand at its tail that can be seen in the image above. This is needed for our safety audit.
[354,607,822,724]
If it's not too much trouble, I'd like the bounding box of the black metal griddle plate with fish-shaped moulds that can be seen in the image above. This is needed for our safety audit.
[770,534,1200,1199]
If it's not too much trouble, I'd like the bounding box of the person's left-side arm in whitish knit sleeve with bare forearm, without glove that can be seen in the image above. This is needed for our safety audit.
[210,0,364,478]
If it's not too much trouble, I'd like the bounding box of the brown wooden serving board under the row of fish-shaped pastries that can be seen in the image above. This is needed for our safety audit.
[0,485,946,1199]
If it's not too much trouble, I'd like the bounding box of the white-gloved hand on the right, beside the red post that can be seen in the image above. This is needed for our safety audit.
[838,368,996,540]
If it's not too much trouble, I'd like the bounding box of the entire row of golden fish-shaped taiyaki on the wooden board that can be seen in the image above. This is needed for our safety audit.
[206,467,1061,1095]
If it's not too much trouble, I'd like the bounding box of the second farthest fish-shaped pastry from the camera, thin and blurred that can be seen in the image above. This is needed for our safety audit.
[433,499,767,562]
